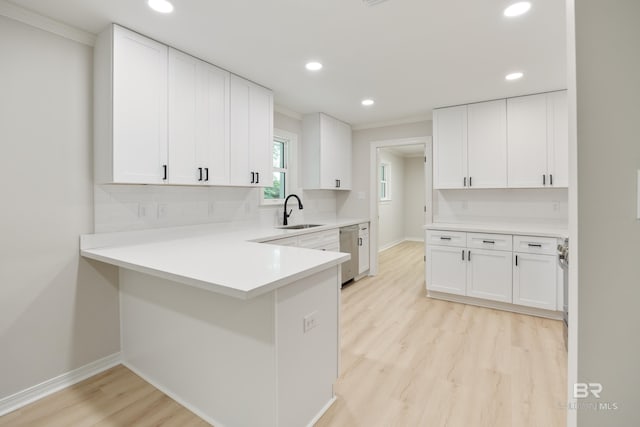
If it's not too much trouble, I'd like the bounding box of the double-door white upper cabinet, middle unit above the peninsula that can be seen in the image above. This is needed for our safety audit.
[169,49,229,185]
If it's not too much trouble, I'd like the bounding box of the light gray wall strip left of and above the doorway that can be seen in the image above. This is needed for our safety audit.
[336,120,432,218]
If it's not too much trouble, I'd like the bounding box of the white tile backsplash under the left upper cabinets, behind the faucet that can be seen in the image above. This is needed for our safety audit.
[94,185,336,233]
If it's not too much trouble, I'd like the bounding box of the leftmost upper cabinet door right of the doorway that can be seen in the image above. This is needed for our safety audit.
[433,105,467,189]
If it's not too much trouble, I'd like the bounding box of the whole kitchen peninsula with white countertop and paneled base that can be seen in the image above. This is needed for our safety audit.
[81,221,361,426]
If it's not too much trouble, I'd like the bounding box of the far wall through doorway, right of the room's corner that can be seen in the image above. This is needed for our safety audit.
[404,157,425,240]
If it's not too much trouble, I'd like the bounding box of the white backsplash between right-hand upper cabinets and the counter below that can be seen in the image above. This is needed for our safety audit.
[433,188,568,228]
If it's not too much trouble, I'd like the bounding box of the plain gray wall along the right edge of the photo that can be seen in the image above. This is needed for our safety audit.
[575,0,640,427]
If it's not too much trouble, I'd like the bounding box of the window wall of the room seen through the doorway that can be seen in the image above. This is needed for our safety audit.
[378,148,405,250]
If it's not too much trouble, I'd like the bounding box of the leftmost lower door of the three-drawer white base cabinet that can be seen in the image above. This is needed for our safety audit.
[425,245,467,295]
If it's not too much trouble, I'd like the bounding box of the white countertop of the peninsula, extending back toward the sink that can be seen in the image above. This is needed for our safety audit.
[80,219,368,299]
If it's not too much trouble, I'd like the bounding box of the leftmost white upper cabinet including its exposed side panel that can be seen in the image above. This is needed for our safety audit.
[94,26,168,184]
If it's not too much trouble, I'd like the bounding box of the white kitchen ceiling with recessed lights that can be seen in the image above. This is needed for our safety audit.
[12,0,566,126]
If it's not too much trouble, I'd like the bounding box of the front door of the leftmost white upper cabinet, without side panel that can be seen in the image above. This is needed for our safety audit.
[113,26,171,184]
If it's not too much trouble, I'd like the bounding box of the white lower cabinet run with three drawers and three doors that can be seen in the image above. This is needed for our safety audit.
[425,230,563,315]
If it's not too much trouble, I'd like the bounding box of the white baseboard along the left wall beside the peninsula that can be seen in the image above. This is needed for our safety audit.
[0,352,121,416]
